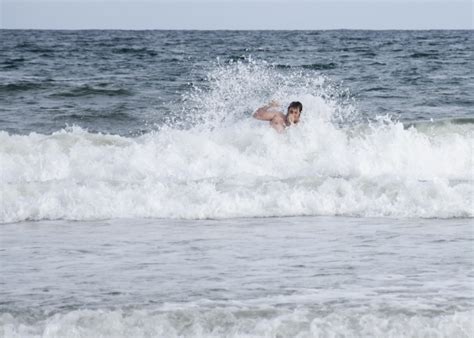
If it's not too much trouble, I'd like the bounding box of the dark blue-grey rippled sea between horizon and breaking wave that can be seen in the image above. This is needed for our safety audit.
[0,30,474,135]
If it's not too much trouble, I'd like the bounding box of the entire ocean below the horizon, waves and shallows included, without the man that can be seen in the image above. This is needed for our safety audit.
[0,30,474,337]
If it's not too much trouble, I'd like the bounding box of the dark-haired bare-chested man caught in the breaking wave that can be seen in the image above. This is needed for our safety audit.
[253,101,303,133]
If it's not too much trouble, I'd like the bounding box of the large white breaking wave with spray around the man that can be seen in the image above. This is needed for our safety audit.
[0,62,474,222]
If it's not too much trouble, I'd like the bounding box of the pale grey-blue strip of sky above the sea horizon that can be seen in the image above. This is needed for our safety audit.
[0,0,474,29]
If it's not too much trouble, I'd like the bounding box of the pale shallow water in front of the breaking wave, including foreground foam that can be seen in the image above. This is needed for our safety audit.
[0,217,474,337]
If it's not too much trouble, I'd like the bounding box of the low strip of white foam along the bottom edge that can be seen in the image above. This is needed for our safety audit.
[0,307,474,338]
